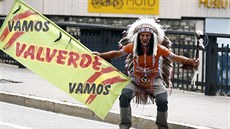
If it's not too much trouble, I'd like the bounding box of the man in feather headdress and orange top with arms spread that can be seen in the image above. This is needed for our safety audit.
[93,18,199,129]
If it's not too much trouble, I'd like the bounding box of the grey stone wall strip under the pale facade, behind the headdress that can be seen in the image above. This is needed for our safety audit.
[47,16,204,32]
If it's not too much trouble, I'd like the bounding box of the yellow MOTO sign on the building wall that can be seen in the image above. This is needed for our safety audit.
[88,0,159,15]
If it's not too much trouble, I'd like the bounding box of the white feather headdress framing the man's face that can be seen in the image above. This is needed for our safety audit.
[127,17,165,55]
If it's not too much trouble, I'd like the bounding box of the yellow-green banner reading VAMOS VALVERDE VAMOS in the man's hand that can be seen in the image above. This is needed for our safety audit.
[0,0,130,119]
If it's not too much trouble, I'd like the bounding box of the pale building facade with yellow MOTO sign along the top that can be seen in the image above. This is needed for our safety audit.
[0,0,230,33]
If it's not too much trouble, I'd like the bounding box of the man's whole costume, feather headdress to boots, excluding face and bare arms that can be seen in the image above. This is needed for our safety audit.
[119,18,174,129]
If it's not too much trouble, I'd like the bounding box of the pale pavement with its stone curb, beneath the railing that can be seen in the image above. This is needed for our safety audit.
[0,63,230,129]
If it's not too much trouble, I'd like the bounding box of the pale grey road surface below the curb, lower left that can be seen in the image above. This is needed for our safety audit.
[0,102,134,129]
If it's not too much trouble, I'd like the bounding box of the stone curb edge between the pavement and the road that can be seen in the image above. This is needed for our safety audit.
[0,91,210,129]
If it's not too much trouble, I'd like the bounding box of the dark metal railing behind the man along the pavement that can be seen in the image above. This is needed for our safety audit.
[0,21,230,95]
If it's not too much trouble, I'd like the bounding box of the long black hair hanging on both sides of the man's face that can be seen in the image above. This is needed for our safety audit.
[137,33,154,56]
